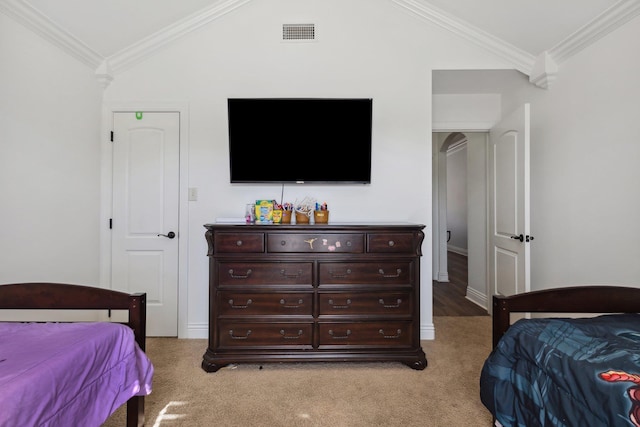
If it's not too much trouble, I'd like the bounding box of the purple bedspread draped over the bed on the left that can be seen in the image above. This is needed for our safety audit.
[0,322,153,427]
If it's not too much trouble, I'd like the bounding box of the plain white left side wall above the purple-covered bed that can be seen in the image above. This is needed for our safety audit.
[0,13,102,285]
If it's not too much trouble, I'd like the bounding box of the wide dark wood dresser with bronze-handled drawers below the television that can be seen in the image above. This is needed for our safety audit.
[202,224,427,372]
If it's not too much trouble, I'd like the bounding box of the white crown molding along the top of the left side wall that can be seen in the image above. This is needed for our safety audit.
[0,0,104,69]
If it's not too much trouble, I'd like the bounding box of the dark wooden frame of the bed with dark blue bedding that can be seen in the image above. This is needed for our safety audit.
[493,286,640,347]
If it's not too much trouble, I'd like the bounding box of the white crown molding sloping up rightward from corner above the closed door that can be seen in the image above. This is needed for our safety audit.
[107,0,251,73]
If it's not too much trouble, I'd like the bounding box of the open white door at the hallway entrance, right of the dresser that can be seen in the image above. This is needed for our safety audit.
[489,104,532,295]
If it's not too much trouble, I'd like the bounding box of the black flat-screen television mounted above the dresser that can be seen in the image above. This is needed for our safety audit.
[228,98,373,184]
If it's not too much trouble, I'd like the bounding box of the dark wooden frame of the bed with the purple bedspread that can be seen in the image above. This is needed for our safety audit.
[0,283,147,427]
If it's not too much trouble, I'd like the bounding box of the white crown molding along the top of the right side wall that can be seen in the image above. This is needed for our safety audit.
[548,0,640,64]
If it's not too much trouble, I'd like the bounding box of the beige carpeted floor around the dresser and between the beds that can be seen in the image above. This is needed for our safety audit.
[104,316,491,427]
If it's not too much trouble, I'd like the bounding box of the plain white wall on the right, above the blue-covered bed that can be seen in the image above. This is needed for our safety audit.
[503,18,640,290]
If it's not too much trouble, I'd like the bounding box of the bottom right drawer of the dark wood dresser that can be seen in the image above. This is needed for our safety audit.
[319,321,413,349]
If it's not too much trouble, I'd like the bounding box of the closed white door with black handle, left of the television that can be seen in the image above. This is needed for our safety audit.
[111,112,180,336]
